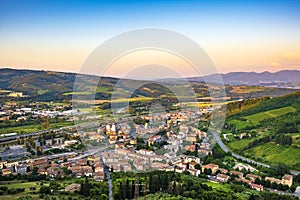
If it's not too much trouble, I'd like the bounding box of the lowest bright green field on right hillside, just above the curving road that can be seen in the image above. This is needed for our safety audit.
[246,143,300,170]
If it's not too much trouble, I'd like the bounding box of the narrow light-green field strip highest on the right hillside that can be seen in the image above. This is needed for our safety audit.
[245,106,296,122]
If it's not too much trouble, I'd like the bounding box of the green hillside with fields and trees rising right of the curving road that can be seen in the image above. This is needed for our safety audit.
[223,91,300,169]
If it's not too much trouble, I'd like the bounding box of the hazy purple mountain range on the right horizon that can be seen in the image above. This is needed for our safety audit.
[189,70,300,89]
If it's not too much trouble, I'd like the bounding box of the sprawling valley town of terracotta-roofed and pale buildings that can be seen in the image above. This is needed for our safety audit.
[0,103,294,199]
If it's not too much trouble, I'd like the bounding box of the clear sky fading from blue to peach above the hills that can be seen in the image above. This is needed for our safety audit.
[0,0,300,76]
